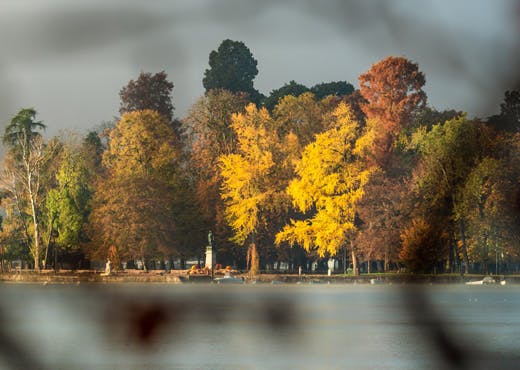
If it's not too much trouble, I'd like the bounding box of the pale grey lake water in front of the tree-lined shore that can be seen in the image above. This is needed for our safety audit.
[0,284,520,370]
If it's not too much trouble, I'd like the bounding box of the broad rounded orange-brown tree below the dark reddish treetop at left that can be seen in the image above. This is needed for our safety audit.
[90,110,183,268]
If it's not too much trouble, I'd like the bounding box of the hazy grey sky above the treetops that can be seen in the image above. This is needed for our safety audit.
[0,0,520,139]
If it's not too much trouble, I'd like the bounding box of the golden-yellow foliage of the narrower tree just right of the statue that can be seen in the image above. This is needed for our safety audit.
[219,104,290,268]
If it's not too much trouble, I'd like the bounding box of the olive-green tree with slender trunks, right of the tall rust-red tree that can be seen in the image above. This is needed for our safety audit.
[412,115,491,272]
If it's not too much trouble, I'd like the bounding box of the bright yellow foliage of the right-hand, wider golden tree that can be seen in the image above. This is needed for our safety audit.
[276,103,373,257]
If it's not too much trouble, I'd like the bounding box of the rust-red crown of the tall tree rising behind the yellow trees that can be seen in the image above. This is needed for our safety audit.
[359,57,426,169]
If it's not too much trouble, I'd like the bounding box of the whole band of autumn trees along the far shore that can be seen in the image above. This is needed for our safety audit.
[0,40,520,273]
